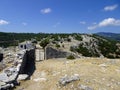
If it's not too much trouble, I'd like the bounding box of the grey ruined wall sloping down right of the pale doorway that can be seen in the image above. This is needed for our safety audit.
[45,47,70,59]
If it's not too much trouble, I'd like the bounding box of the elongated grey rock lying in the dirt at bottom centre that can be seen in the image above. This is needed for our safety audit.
[59,74,80,86]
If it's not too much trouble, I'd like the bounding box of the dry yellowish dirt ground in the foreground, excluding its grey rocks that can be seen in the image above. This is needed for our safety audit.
[15,58,120,90]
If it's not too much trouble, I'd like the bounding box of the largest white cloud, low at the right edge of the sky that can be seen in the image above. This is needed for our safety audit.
[88,18,120,30]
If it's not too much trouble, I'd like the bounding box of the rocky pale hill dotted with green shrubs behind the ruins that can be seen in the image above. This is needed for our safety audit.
[39,33,120,58]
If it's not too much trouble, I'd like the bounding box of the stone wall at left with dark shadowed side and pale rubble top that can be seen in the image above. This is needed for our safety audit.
[0,49,35,90]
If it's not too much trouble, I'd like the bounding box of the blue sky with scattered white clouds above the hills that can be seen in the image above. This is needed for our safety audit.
[0,0,120,33]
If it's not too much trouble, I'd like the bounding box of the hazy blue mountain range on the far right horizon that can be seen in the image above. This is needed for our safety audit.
[96,32,120,41]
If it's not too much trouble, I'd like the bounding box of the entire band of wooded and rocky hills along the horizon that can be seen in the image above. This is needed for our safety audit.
[0,32,120,58]
